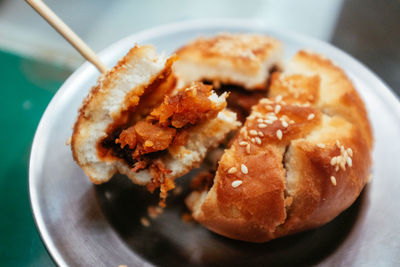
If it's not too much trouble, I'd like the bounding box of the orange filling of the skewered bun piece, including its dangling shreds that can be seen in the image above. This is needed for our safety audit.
[101,83,225,205]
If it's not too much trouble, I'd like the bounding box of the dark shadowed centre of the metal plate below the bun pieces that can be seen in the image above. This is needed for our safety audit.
[95,172,368,266]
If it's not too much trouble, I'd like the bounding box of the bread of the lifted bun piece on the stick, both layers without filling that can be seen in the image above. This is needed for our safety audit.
[71,45,240,191]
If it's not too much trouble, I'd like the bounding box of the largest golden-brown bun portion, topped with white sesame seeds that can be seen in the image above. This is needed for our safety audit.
[186,51,373,242]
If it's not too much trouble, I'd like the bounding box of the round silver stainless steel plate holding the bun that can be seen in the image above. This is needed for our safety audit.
[29,20,400,266]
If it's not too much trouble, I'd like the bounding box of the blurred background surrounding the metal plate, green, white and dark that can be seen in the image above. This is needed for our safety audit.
[0,0,400,266]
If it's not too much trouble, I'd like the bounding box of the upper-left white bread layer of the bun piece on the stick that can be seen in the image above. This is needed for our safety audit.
[71,45,173,184]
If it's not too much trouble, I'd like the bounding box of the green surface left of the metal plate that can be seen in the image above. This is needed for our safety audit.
[0,51,70,266]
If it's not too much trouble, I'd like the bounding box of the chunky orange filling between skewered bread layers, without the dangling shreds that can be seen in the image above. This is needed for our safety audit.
[115,83,223,171]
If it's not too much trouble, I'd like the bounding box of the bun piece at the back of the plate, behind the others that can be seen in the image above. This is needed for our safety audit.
[174,33,282,90]
